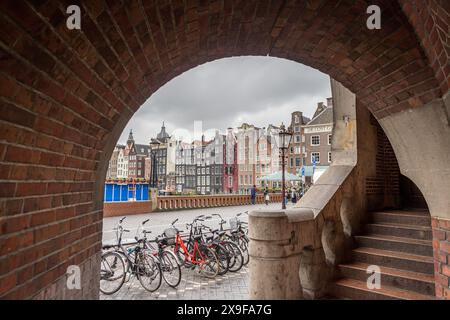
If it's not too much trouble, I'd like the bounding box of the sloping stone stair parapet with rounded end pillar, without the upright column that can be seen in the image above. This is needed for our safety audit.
[249,166,359,300]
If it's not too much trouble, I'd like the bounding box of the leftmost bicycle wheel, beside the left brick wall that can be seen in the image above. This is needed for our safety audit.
[100,251,126,295]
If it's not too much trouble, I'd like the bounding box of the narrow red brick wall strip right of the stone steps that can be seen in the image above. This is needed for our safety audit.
[431,218,450,299]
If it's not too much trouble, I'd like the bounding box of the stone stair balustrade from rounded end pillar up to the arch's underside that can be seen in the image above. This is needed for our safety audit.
[249,80,368,300]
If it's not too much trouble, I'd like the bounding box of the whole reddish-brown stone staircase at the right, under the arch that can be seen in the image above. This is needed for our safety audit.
[332,209,435,300]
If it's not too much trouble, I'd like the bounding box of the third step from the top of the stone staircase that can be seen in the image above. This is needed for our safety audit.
[355,234,433,257]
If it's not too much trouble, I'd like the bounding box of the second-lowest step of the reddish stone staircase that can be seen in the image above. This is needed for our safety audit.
[339,262,435,296]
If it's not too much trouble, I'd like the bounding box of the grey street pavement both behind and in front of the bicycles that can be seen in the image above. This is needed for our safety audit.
[100,203,292,300]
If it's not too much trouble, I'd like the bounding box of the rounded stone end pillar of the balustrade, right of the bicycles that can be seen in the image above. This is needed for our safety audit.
[249,210,314,299]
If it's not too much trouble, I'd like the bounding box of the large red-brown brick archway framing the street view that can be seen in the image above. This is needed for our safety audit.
[0,0,449,298]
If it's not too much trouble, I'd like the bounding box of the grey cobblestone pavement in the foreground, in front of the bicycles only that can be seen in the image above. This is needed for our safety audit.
[100,267,248,300]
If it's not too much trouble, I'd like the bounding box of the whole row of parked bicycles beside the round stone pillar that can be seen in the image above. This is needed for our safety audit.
[100,212,249,294]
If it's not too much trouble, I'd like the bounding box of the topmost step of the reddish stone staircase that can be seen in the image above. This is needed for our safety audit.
[371,211,431,227]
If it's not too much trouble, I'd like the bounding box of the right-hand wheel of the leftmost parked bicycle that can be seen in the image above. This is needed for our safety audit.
[136,251,162,292]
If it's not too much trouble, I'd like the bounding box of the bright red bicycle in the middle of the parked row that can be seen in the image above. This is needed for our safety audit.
[164,217,219,278]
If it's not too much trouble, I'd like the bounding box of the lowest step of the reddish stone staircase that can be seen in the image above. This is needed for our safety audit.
[332,278,434,300]
